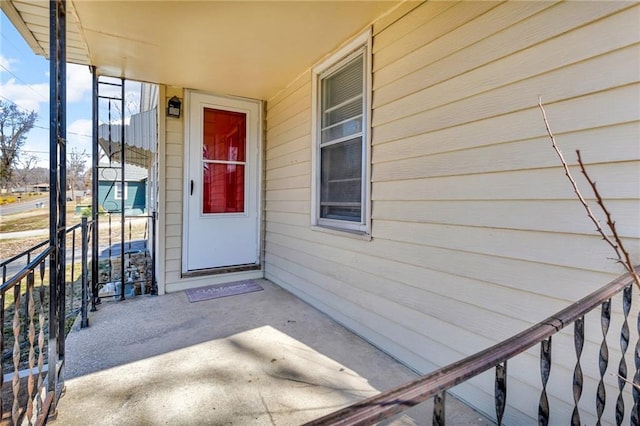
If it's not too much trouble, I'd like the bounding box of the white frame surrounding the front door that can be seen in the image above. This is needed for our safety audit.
[181,89,264,277]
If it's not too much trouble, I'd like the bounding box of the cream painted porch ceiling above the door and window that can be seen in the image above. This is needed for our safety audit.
[2,0,400,99]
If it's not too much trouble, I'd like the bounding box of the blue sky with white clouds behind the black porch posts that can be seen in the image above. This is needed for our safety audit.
[0,12,139,167]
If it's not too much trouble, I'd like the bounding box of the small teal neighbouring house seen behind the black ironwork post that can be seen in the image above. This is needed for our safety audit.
[98,163,148,216]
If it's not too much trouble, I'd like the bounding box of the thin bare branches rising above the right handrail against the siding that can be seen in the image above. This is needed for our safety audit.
[538,97,640,289]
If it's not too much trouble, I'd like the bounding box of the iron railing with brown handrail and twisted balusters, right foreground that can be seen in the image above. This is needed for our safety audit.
[307,267,640,426]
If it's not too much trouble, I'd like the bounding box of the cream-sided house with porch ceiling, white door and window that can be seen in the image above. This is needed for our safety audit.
[2,0,640,424]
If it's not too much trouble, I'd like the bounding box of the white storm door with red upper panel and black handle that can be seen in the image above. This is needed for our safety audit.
[183,92,260,272]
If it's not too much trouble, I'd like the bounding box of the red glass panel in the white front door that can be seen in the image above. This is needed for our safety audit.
[202,108,246,214]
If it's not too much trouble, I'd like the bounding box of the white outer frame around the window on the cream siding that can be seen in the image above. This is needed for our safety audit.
[311,29,371,237]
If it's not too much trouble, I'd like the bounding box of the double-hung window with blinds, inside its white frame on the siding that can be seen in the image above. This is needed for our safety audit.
[312,30,369,232]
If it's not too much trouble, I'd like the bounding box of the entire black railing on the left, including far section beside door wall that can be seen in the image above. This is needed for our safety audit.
[0,208,158,424]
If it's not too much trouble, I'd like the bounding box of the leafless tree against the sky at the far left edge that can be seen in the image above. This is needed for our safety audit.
[0,100,38,188]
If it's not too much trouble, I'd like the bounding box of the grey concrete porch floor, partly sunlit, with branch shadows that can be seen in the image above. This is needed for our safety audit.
[54,280,493,425]
